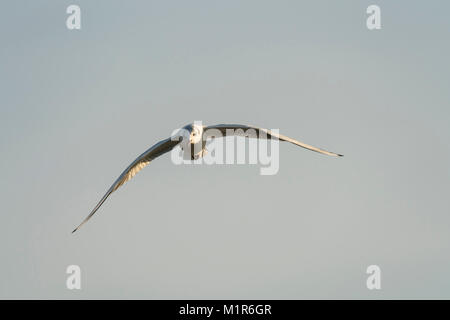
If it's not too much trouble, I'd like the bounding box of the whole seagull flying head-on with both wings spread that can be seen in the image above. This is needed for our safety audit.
[72,123,343,233]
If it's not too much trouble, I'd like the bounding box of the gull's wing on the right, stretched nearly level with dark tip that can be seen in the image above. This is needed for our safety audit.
[203,124,342,157]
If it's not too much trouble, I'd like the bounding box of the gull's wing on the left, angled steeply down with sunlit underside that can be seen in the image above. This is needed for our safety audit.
[72,138,181,233]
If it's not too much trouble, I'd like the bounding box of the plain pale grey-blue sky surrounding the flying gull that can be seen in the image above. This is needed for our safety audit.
[0,0,450,299]
